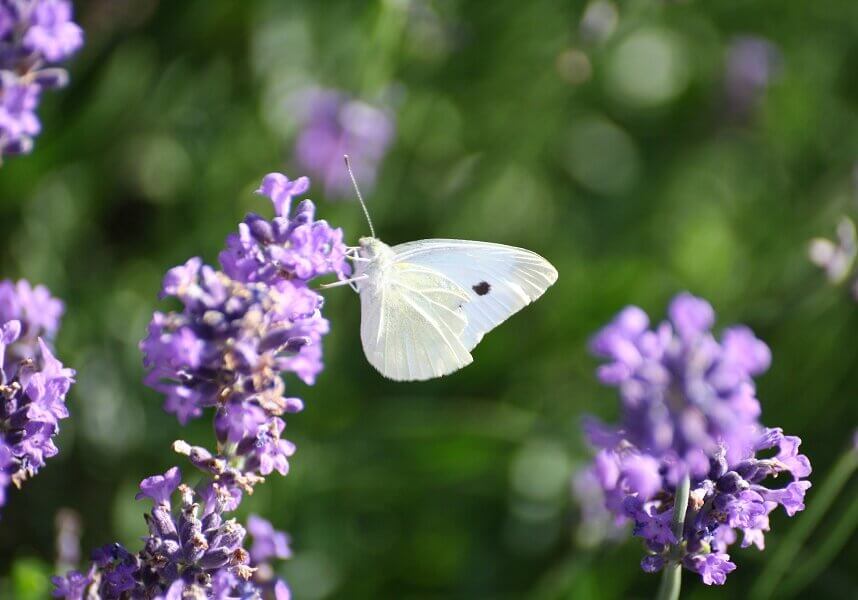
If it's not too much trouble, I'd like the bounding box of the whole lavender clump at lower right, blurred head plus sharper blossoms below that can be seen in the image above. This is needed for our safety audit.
[585,294,811,585]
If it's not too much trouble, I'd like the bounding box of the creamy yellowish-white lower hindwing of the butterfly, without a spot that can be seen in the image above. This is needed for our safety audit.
[360,262,473,381]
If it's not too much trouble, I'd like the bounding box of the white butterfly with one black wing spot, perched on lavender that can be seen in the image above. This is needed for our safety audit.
[325,157,557,381]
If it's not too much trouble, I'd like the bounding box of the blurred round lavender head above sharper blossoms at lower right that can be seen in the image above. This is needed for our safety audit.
[591,293,771,476]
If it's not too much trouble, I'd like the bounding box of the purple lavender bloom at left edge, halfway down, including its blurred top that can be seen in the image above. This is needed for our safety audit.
[0,280,74,506]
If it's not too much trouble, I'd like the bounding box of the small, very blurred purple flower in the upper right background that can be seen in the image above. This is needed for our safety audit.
[724,36,782,120]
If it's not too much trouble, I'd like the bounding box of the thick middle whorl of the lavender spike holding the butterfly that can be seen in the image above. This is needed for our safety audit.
[140,258,320,426]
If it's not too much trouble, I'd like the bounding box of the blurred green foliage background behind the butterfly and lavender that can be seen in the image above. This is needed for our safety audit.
[0,0,858,599]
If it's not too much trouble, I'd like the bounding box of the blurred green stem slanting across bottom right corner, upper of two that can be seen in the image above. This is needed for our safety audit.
[749,448,858,600]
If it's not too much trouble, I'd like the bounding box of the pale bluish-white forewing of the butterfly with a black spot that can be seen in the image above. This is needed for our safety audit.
[392,239,557,352]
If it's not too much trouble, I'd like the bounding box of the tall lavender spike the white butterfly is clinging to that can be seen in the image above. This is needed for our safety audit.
[141,173,346,498]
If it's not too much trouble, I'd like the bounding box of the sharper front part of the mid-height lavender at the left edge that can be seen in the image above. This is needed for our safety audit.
[0,302,74,506]
